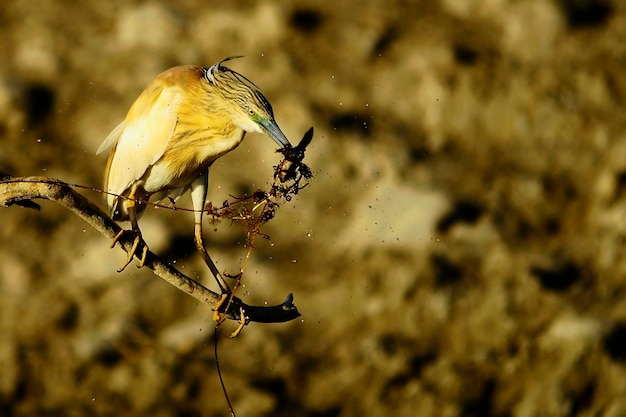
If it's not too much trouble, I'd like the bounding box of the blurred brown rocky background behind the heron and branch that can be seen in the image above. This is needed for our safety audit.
[0,0,626,417]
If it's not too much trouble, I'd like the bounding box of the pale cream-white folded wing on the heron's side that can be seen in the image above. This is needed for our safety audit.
[98,77,183,208]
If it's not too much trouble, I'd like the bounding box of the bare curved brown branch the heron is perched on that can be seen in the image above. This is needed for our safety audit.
[0,177,300,323]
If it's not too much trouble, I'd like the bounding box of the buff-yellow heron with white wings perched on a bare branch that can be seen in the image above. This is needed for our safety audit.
[97,57,291,293]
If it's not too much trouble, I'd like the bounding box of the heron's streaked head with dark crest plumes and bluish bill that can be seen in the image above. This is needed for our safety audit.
[205,56,291,148]
